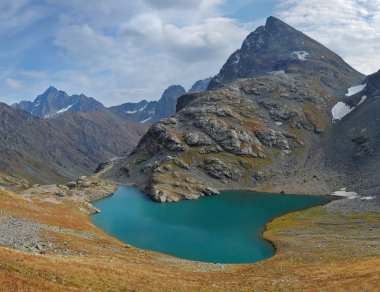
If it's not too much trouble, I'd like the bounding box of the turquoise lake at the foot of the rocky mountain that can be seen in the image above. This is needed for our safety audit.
[92,187,330,263]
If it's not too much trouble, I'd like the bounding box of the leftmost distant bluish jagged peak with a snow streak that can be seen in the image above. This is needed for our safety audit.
[12,86,105,118]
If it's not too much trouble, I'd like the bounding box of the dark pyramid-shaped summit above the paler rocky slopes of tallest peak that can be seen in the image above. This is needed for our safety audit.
[208,17,357,89]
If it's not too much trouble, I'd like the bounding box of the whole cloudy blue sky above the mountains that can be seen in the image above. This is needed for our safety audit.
[0,0,380,106]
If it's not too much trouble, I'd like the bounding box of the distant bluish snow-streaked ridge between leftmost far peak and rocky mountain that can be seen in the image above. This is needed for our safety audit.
[109,85,186,124]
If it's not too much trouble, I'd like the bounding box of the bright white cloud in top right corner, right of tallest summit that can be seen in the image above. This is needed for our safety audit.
[277,0,380,74]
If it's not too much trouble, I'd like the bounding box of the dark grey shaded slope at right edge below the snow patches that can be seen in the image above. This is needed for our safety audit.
[325,70,380,196]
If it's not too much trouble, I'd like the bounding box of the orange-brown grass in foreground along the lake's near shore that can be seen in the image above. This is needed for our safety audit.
[0,191,380,291]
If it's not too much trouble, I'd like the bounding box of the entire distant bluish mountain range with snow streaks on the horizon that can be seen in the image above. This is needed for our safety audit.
[12,78,211,124]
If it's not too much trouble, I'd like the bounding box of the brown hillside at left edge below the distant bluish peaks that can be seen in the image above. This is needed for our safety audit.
[0,103,146,183]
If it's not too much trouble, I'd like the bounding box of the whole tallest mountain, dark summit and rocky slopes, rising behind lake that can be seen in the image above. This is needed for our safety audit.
[99,17,365,202]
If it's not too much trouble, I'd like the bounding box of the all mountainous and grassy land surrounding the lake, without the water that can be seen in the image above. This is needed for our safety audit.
[0,17,380,291]
